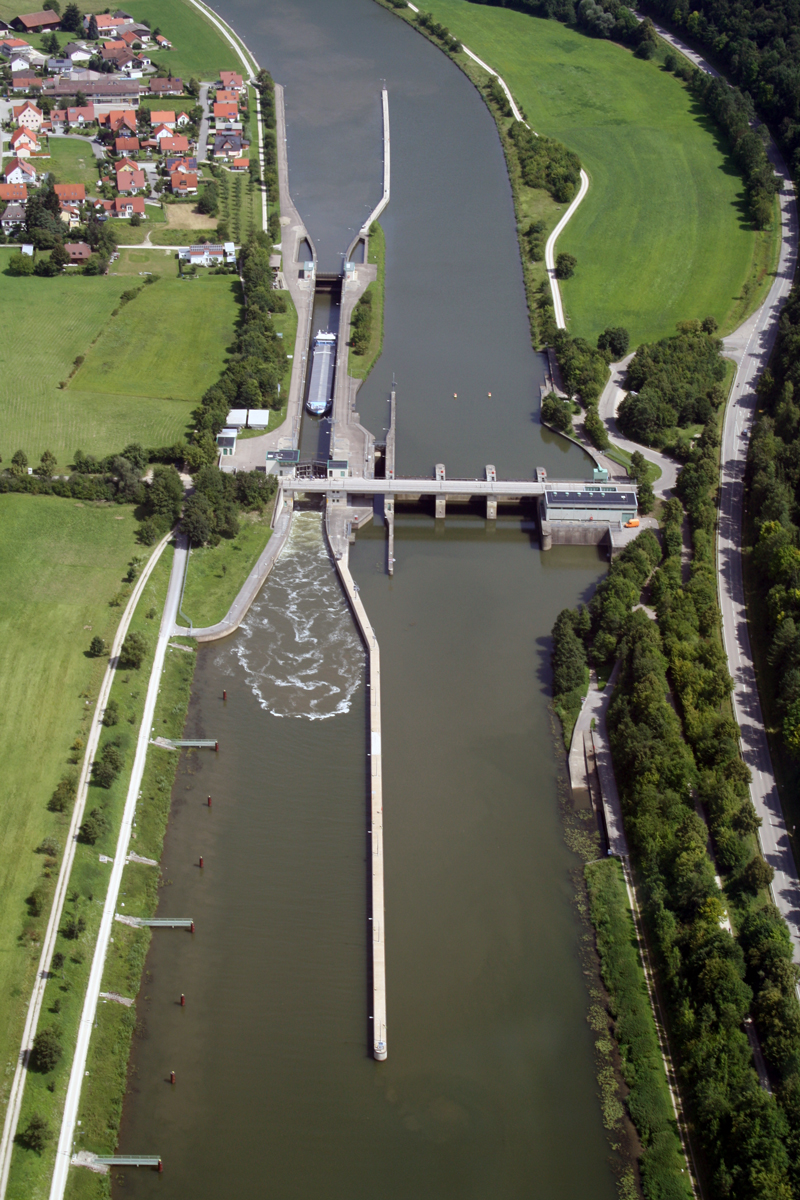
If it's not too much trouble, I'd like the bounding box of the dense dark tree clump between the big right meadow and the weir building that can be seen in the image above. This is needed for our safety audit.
[618,317,724,446]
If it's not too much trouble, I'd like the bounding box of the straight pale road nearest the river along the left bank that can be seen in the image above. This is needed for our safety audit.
[50,535,187,1200]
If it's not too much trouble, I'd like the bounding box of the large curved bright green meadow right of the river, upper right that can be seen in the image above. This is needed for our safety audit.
[412,0,771,346]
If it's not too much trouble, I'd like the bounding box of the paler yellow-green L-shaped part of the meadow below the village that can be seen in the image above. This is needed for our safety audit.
[0,270,192,469]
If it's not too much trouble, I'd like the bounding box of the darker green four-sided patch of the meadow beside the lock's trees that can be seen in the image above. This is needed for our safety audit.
[70,275,241,403]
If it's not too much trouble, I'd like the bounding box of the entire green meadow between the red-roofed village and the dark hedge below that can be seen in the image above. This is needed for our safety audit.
[0,270,239,470]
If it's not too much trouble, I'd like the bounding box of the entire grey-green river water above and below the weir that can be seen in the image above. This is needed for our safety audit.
[115,0,615,1200]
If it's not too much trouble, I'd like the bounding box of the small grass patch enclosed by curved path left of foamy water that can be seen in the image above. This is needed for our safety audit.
[178,511,272,632]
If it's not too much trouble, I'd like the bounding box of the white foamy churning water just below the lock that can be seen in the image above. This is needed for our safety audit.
[217,512,365,721]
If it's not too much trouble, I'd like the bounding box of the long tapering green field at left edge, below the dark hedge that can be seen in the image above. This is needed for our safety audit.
[0,492,142,1110]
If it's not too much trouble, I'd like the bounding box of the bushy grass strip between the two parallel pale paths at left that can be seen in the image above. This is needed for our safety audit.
[7,549,173,1200]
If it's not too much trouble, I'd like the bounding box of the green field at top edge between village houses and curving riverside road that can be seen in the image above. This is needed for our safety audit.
[126,0,242,81]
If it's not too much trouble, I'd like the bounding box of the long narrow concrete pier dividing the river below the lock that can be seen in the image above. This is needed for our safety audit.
[333,544,387,1061]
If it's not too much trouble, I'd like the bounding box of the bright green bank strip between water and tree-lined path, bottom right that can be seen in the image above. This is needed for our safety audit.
[584,858,692,1200]
